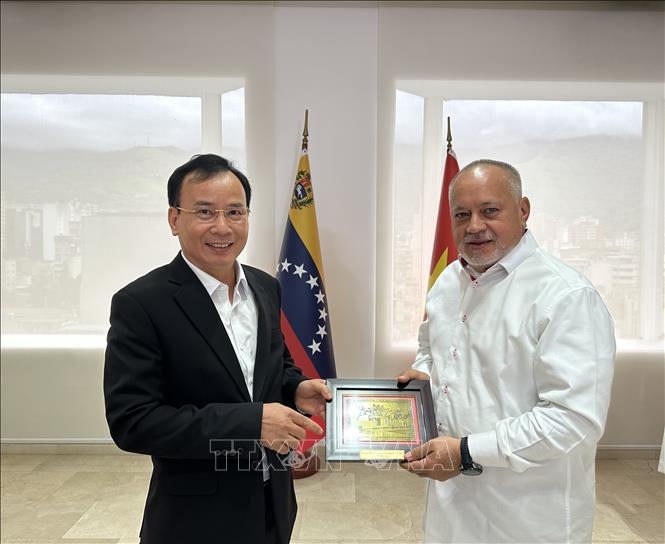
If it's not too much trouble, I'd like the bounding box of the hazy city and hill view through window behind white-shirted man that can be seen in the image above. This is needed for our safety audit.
[392,91,652,344]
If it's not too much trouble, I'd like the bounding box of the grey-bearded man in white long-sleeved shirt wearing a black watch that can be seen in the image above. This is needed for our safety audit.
[398,160,615,543]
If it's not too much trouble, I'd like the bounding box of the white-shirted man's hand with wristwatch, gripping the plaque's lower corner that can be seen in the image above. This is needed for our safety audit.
[400,436,462,482]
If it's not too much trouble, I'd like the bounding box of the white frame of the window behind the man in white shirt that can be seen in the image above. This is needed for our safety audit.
[384,80,665,356]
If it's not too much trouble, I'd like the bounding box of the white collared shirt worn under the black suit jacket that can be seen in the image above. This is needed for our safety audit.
[182,254,258,400]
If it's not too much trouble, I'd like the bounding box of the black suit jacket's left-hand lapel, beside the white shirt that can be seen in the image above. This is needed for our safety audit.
[170,254,253,402]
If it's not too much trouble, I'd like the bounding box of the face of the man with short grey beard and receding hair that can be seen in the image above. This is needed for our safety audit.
[450,165,531,272]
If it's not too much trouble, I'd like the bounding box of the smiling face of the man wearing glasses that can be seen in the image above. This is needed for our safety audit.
[169,172,249,285]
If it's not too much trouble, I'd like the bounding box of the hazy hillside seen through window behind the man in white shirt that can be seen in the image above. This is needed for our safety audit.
[395,136,643,236]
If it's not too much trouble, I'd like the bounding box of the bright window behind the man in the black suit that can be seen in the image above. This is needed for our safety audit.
[1,76,245,346]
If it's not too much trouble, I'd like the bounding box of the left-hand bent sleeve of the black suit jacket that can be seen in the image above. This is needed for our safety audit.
[104,292,262,459]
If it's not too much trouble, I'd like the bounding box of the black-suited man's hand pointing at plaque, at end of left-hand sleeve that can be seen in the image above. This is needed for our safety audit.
[261,402,323,453]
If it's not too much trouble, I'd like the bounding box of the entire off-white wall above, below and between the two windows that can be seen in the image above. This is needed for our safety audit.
[0,2,663,445]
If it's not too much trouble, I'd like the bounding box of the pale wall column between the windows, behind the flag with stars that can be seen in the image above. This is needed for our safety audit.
[274,7,377,377]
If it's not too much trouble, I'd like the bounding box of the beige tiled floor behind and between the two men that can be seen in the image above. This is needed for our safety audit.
[1,453,665,544]
